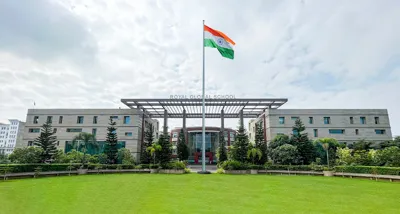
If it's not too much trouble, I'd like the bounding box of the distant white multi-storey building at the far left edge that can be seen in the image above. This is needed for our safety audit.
[0,119,25,154]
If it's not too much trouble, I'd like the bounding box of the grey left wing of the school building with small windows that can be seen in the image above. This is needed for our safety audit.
[17,109,159,158]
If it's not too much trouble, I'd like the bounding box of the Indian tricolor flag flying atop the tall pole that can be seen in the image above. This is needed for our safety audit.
[204,25,235,59]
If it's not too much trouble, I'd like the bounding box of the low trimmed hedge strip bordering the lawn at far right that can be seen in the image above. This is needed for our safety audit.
[335,166,400,175]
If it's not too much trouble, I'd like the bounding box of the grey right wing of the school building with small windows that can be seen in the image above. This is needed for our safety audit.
[248,109,392,144]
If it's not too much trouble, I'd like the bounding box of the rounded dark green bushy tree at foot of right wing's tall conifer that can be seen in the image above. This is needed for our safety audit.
[271,144,298,165]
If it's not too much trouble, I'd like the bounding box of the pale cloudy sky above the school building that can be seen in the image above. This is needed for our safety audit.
[0,0,400,135]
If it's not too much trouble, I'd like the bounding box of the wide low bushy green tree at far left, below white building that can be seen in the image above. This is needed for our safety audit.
[8,146,43,163]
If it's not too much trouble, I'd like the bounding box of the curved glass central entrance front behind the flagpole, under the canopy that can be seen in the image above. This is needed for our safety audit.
[170,127,236,164]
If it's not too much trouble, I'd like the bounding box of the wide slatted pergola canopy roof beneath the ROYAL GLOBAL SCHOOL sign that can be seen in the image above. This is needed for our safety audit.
[121,98,287,118]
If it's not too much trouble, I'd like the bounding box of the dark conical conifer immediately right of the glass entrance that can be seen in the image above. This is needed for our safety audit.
[230,122,249,163]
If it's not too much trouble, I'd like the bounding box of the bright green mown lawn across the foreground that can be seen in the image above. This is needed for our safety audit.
[0,174,400,214]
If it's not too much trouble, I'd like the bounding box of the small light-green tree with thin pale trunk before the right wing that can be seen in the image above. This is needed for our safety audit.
[314,138,340,167]
